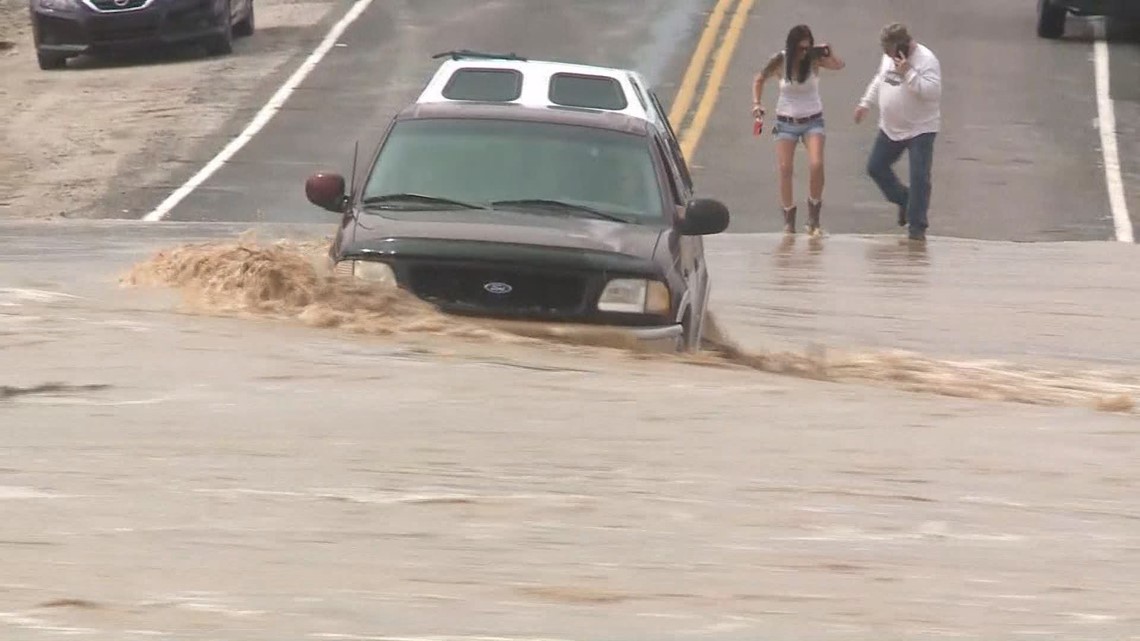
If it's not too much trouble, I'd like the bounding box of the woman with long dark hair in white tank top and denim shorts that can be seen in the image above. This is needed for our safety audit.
[752,24,846,234]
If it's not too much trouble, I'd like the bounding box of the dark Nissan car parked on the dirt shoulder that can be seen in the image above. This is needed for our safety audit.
[29,0,254,70]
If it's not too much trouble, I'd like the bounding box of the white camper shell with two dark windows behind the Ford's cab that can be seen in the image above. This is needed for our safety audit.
[416,49,693,189]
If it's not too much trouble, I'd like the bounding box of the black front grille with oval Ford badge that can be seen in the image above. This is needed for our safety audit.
[408,265,586,318]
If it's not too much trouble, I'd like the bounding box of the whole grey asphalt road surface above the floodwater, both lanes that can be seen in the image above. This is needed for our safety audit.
[108,0,1140,241]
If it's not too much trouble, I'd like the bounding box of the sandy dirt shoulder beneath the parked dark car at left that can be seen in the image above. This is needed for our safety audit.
[0,0,344,219]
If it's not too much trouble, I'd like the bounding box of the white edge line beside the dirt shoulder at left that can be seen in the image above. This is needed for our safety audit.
[143,0,373,222]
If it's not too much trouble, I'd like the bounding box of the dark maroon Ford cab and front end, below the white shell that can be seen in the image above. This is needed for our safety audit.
[304,100,728,349]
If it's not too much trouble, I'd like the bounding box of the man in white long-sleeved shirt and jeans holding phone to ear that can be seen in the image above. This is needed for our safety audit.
[855,23,942,241]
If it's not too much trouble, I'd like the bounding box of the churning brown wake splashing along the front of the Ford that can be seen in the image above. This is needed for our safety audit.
[122,235,1140,413]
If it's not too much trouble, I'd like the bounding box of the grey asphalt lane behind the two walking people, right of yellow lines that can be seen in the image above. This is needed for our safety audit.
[694,0,1140,241]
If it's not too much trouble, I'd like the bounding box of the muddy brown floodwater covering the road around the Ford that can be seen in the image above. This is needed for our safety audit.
[0,224,1140,641]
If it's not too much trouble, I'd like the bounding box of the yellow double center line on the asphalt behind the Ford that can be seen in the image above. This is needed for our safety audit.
[669,0,756,162]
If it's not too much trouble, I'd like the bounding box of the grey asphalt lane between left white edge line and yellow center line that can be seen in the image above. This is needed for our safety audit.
[127,0,709,222]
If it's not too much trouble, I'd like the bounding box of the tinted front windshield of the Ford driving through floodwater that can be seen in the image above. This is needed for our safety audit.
[363,119,663,222]
